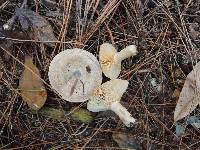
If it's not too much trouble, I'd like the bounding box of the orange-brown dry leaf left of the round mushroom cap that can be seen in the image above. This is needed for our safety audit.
[19,56,47,110]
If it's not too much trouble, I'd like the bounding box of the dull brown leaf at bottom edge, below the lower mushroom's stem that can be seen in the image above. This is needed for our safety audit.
[112,133,142,150]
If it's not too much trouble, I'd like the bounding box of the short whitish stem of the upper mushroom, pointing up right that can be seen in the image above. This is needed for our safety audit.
[114,45,137,63]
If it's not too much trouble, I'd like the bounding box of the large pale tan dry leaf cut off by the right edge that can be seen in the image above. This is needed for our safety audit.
[174,62,200,122]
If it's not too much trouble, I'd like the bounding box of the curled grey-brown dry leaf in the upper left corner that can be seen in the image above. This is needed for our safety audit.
[4,8,57,47]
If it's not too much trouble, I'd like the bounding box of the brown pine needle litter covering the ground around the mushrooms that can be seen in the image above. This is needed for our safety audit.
[0,0,200,149]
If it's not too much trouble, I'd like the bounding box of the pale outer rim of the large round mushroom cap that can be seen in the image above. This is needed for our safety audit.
[48,48,102,102]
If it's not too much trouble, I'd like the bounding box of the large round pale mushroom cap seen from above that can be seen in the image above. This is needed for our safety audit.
[48,48,102,102]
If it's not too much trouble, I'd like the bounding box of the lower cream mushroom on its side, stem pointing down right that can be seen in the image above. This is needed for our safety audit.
[87,79,135,127]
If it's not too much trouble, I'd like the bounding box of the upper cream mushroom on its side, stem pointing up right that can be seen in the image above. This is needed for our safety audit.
[99,43,137,79]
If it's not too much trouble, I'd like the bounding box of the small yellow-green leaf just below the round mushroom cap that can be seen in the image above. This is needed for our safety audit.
[70,108,93,123]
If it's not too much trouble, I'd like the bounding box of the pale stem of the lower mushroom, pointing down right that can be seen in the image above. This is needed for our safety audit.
[110,102,136,127]
